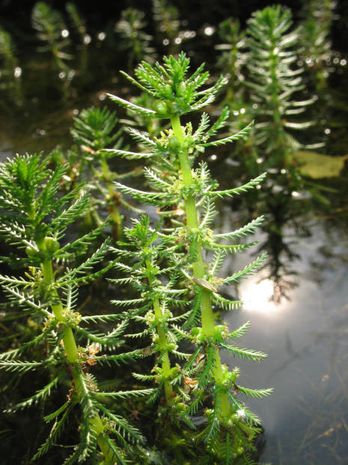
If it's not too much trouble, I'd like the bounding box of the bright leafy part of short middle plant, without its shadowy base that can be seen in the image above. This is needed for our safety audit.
[113,216,186,403]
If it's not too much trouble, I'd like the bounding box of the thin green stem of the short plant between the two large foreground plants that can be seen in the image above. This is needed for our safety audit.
[146,260,173,403]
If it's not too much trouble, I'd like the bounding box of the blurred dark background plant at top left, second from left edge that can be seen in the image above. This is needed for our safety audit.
[32,2,71,70]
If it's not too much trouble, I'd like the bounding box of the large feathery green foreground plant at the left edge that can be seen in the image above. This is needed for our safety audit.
[0,155,146,465]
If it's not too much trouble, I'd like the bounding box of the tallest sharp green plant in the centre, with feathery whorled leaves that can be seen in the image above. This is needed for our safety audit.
[110,53,270,464]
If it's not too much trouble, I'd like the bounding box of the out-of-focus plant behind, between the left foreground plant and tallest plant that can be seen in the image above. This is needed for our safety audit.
[70,107,122,239]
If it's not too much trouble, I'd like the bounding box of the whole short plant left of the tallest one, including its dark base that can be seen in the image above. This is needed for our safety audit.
[113,216,198,454]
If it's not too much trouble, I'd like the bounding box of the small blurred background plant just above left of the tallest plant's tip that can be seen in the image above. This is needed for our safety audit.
[115,8,154,67]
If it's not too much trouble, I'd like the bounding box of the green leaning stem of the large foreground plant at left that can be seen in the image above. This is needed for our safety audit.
[37,239,115,465]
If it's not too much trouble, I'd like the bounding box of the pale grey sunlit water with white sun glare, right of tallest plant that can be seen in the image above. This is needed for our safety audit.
[225,220,348,465]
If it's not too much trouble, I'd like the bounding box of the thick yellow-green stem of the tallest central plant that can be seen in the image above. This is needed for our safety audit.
[171,116,232,419]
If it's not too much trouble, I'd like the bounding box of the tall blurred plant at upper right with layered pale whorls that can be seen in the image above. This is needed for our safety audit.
[246,5,315,172]
